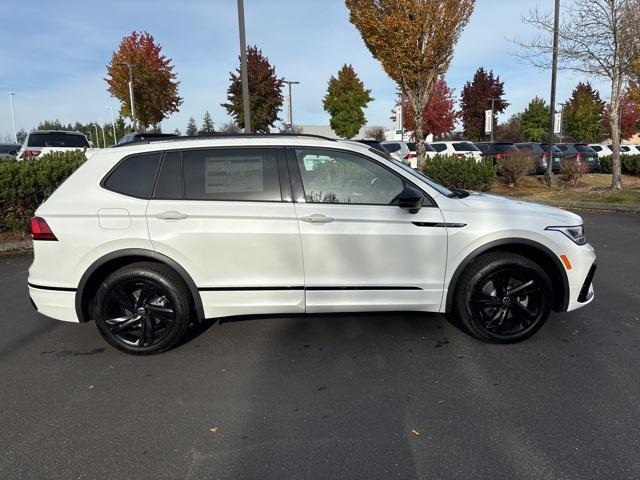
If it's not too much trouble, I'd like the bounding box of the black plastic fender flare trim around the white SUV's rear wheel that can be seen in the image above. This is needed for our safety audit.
[75,248,204,323]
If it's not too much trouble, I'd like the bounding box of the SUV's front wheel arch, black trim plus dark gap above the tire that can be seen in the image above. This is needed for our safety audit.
[445,238,570,312]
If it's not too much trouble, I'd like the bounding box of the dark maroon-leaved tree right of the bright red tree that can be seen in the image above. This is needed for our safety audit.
[460,67,509,140]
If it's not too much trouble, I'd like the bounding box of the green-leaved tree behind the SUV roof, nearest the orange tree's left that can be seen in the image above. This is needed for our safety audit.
[322,64,373,138]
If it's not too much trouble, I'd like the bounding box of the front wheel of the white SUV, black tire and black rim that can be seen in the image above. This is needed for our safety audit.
[454,252,553,343]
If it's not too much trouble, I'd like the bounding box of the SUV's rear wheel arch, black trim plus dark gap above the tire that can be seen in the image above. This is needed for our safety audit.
[75,248,204,323]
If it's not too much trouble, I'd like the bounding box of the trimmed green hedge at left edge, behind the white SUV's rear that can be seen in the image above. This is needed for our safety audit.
[0,151,86,231]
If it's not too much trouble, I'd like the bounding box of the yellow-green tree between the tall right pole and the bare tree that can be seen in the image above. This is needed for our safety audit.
[562,82,605,143]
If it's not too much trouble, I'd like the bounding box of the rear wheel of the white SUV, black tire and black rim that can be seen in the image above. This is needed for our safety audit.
[93,262,192,355]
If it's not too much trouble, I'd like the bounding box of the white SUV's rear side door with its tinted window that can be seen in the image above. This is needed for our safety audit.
[147,148,304,317]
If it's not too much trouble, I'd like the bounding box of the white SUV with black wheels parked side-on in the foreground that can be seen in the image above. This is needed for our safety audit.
[29,135,595,354]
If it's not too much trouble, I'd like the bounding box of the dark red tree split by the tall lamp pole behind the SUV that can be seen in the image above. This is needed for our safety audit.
[222,45,284,133]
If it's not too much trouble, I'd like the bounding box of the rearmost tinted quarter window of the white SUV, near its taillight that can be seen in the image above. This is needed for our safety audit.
[104,152,162,198]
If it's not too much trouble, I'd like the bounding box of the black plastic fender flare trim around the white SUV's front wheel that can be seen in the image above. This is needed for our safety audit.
[445,238,570,312]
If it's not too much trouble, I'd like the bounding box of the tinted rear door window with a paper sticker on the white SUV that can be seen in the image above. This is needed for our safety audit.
[182,148,282,202]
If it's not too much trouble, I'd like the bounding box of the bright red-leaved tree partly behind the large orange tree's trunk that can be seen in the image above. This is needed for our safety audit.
[402,76,460,137]
